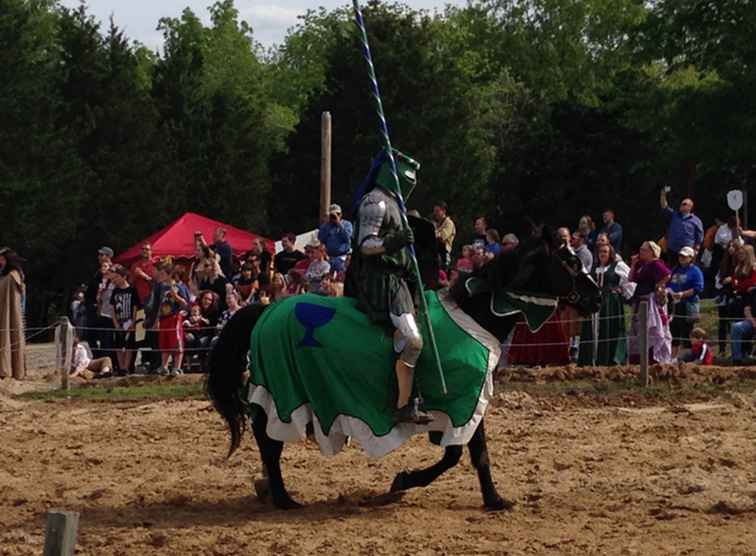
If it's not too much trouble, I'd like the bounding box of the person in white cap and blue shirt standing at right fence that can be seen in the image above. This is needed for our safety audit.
[667,246,704,357]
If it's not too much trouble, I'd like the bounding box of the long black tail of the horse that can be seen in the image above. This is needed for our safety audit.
[207,304,265,457]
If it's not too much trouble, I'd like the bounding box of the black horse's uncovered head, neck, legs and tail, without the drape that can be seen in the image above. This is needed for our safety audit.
[207,229,600,510]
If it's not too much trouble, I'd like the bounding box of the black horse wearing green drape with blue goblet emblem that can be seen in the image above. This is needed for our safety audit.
[208,224,600,510]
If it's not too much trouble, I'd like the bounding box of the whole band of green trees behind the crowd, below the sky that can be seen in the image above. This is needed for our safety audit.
[0,0,756,323]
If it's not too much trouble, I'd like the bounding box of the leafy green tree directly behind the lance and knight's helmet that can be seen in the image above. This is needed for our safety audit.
[271,2,509,235]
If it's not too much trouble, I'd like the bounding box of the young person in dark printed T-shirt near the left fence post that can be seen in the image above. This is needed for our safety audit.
[110,265,139,375]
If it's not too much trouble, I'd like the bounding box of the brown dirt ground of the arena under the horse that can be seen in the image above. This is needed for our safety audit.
[0,350,756,556]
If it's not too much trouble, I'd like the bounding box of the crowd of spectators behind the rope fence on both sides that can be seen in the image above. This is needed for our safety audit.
[10,190,756,382]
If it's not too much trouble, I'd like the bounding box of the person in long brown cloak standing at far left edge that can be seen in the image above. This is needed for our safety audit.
[0,247,26,380]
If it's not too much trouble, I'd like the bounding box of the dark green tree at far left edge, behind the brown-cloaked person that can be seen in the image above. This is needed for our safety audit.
[0,0,89,322]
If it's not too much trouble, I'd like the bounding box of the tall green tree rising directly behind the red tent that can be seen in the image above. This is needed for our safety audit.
[154,0,294,229]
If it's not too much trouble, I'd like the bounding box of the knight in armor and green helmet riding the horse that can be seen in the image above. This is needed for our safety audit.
[346,150,432,424]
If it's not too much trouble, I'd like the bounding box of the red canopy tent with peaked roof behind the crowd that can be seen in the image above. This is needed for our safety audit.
[114,212,274,265]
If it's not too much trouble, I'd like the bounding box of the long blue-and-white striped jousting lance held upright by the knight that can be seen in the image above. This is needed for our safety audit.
[352,0,448,395]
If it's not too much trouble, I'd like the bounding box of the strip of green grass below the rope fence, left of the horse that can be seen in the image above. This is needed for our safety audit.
[17,382,206,402]
